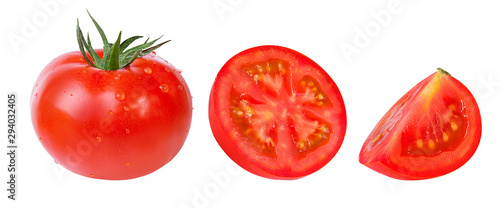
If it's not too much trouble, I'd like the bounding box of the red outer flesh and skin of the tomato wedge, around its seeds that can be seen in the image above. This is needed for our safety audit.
[359,72,482,180]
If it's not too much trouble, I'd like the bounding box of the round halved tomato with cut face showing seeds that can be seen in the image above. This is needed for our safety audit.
[209,46,346,179]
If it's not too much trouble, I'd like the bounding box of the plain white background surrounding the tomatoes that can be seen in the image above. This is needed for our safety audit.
[0,0,500,208]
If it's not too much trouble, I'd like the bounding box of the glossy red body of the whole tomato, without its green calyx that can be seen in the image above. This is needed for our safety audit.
[31,50,192,180]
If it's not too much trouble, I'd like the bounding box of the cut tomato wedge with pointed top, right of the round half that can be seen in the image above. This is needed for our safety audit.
[359,69,481,180]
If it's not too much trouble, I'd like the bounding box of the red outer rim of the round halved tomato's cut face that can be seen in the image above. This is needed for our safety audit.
[209,45,347,180]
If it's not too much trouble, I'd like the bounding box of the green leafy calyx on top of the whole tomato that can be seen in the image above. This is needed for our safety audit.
[76,11,170,71]
